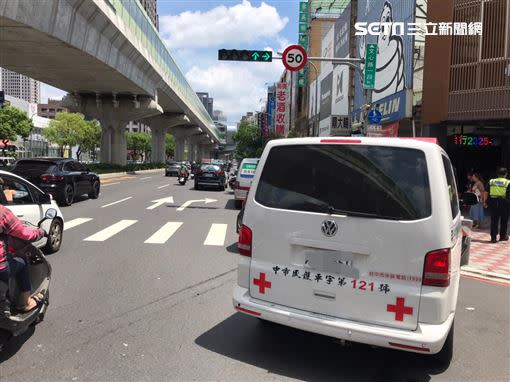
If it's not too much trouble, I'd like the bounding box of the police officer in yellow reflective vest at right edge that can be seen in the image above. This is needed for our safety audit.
[488,167,510,243]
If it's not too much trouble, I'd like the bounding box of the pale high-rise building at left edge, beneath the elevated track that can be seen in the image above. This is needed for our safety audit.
[0,68,41,103]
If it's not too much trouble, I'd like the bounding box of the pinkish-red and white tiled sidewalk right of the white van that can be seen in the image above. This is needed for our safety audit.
[463,225,510,279]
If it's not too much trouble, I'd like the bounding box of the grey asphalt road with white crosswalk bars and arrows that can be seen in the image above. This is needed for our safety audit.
[0,174,510,382]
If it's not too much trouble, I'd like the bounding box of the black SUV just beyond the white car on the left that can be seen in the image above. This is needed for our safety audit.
[12,158,101,206]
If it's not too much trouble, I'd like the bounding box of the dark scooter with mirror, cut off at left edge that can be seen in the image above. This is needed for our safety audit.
[0,208,57,351]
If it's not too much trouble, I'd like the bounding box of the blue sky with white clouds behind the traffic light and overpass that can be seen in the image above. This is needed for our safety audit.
[41,0,299,122]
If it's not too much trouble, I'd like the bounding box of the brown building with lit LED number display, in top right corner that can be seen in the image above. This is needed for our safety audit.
[422,0,510,181]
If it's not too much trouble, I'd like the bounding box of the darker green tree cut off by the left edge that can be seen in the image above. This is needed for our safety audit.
[0,106,34,156]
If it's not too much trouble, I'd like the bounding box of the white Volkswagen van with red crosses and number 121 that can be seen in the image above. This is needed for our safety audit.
[233,138,472,362]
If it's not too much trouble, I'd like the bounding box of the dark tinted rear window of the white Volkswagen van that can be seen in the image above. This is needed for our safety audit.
[255,145,431,220]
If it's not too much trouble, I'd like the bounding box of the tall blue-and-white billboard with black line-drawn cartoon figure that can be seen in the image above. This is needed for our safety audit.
[353,0,416,123]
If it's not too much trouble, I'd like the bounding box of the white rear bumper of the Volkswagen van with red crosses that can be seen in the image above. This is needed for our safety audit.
[232,286,455,354]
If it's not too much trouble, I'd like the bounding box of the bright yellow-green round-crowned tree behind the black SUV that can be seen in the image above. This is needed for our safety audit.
[43,113,88,156]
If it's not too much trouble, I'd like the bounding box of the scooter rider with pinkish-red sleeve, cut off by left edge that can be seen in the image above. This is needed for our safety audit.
[0,204,46,312]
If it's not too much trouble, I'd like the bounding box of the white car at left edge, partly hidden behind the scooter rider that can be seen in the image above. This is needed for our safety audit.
[0,170,64,253]
